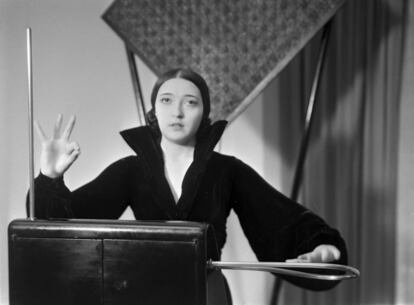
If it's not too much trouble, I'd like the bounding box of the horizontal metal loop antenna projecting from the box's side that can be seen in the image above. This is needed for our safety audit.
[207,260,360,281]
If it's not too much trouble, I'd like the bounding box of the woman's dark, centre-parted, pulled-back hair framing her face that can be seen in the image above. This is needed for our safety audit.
[147,68,210,136]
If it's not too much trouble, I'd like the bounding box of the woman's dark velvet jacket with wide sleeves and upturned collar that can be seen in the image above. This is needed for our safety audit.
[29,121,347,288]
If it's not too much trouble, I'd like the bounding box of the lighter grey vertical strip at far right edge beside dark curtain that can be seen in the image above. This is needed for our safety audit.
[395,1,414,304]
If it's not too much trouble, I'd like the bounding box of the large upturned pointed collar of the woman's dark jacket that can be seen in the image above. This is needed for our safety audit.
[121,121,227,220]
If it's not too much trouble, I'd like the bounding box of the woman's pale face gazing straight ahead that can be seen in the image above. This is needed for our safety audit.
[155,78,204,145]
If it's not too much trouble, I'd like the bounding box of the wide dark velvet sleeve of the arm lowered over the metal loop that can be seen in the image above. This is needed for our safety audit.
[232,159,347,290]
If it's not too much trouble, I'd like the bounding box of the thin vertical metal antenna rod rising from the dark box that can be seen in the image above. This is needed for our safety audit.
[26,28,35,220]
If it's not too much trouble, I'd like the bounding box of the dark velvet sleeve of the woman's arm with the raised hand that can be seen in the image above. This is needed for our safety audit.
[26,158,133,219]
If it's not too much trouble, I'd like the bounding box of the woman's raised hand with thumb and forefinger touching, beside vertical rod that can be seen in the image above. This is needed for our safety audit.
[35,114,80,178]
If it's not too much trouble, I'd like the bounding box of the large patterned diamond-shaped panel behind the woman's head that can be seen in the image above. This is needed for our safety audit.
[103,0,344,121]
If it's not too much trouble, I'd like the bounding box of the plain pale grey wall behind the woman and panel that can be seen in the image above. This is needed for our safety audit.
[0,0,292,304]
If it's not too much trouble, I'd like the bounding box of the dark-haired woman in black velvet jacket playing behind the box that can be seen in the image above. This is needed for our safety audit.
[30,69,347,302]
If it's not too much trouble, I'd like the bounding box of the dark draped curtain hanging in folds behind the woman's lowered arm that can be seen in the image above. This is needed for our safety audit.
[268,0,414,305]
